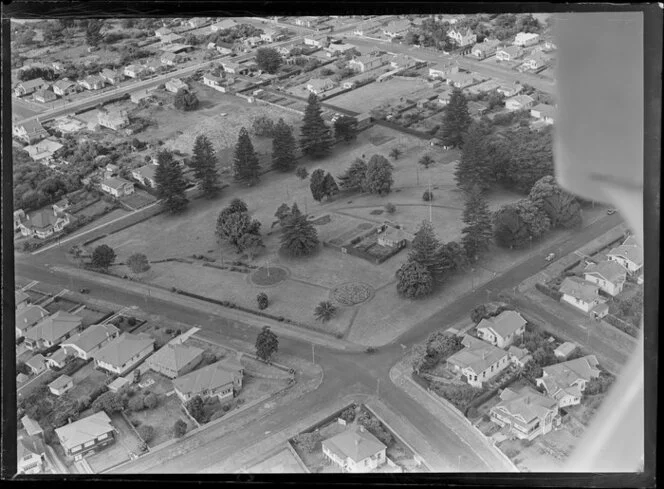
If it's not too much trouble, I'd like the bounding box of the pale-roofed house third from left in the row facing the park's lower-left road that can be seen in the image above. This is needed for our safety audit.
[92,333,154,375]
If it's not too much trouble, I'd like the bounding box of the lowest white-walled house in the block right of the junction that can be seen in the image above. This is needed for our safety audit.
[489,386,561,440]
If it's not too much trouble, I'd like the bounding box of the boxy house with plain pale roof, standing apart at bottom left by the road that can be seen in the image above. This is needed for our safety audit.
[55,411,115,460]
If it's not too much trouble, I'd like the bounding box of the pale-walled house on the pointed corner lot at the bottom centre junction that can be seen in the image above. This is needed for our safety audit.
[322,426,387,473]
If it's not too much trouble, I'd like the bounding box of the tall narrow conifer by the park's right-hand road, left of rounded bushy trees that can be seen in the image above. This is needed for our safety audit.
[461,189,493,262]
